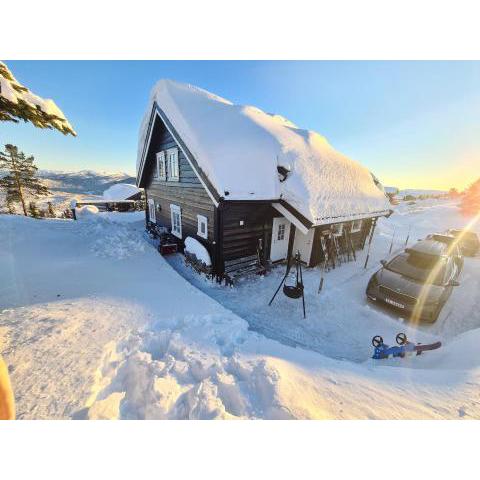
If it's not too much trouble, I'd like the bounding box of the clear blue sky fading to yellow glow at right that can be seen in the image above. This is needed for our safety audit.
[0,60,480,190]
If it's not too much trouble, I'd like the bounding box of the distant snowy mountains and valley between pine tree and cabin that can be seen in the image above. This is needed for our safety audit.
[38,170,135,195]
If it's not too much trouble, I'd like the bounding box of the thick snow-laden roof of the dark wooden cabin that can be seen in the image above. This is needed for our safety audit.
[137,80,389,225]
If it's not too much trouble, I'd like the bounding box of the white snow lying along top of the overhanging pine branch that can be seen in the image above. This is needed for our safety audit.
[0,62,76,135]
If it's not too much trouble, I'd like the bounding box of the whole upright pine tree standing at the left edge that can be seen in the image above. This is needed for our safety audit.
[0,144,50,216]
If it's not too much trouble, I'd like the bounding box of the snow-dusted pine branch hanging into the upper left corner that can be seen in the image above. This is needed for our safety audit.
[0,62,77,136]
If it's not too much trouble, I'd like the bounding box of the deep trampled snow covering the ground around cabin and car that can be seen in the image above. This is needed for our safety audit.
[0,201,480,419]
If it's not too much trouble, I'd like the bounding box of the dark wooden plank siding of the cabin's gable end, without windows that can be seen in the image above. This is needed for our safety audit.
[145,114,215,244]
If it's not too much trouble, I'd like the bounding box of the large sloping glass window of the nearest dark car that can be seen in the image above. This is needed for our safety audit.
[385,253,446,285]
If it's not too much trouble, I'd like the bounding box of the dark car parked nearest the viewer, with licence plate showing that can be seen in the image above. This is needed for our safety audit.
[366,239,463,323]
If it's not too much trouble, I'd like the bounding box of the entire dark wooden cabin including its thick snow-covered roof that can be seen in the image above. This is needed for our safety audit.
[137,80,390,275]
